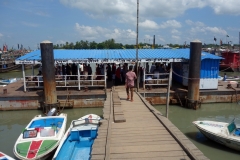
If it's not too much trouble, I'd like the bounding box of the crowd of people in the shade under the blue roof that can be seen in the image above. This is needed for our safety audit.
[38,63,170,85]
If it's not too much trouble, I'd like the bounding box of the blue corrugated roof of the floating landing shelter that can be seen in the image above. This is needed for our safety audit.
[16,48,222,64]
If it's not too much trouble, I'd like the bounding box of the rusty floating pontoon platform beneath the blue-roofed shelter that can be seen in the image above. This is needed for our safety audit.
[0,80,240,110]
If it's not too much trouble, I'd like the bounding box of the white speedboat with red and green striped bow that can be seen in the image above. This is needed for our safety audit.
[13,108,67,160]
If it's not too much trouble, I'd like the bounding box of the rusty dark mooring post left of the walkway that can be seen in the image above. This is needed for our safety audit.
[40,41,59,112]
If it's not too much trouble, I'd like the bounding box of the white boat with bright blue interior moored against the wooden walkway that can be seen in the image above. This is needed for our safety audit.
[53,114,101,160]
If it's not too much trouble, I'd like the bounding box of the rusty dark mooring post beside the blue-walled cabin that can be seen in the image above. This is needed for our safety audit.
[186,40,202,109]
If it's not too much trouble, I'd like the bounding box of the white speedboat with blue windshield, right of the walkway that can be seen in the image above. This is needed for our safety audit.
[193,120,240,151]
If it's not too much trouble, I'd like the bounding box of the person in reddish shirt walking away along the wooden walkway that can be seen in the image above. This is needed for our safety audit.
[125,66,137,102]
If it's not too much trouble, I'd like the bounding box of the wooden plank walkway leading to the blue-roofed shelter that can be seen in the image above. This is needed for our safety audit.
[91,87,208,160]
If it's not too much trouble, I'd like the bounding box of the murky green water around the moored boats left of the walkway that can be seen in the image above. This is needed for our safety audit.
[0,108,103,157]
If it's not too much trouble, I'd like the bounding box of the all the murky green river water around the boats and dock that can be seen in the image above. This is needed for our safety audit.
[0,69,240,160]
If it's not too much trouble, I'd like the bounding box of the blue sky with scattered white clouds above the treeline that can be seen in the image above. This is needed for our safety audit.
[0,0,240,50]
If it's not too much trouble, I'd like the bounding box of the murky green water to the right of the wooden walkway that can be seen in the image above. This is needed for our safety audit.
[155,103,240,160]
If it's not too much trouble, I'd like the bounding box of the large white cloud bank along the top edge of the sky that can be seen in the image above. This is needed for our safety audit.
[60,0,240,23]
